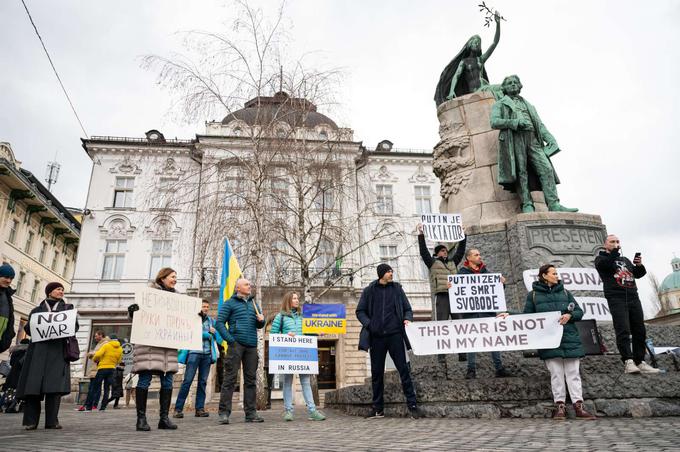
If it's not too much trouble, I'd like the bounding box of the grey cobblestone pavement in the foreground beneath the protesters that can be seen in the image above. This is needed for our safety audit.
[0,404,680,452]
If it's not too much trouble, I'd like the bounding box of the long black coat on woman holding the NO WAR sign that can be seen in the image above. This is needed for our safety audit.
[17,300,78,399]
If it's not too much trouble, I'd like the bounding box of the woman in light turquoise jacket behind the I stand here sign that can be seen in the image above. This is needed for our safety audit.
[269,292,326,421]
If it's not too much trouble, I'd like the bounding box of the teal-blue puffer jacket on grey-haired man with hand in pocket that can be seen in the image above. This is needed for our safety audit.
[215,294,265,347]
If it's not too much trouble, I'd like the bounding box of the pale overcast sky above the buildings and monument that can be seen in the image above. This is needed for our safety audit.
[0,0,680,316]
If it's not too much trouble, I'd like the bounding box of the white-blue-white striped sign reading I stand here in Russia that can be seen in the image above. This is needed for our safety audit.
[269,334,319,374]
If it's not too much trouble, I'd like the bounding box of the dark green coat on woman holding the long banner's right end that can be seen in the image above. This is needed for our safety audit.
[524,281,585,359]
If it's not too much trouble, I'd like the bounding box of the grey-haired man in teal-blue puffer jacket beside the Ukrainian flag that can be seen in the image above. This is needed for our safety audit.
[215,278,265,424]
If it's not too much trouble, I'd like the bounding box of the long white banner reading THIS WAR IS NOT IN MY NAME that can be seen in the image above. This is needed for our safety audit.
[406,311,562,355]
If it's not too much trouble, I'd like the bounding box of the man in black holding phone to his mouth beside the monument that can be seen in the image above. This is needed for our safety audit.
[595,234,660,374]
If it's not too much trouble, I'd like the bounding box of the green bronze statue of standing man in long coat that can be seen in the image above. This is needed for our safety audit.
[490,75,578,213]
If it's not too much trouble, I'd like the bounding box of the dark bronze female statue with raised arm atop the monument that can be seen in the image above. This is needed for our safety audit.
[434,13,501,106]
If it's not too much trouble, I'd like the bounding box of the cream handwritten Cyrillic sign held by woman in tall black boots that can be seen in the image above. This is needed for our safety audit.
[130,287,203,350]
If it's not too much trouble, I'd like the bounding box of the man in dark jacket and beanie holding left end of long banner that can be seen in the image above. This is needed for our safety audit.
[356,264,422,419]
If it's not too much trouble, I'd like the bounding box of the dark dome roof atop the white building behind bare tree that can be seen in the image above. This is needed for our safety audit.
[222,92,338,130]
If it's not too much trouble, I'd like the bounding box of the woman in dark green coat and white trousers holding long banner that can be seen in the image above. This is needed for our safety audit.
[500,264,596,420]
